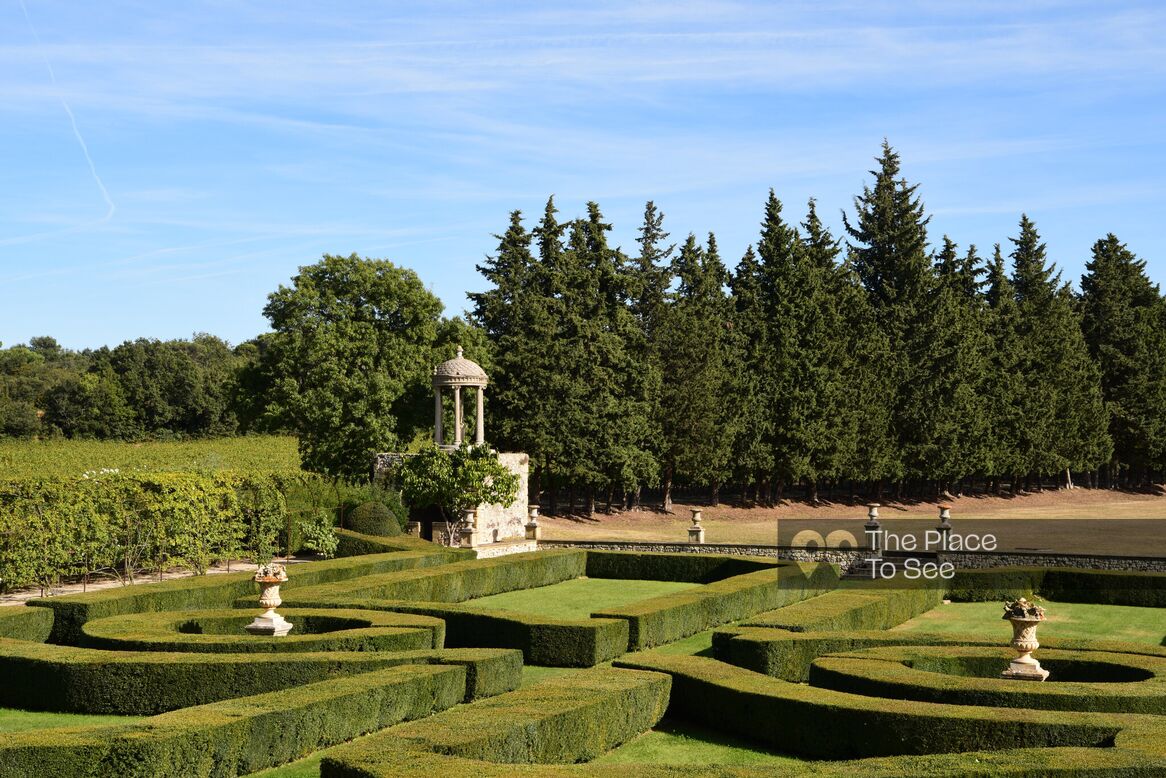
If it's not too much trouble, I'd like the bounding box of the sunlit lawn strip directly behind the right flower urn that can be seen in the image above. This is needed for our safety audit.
[894,600,1166,645]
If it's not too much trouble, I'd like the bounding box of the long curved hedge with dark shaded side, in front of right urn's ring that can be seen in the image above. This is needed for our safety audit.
[616,652,1133,759]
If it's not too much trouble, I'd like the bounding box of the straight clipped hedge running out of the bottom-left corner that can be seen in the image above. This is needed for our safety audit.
[0,665,466,778]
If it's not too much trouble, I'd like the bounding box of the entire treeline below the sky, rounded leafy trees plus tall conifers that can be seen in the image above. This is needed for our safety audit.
[0,145,1166,510]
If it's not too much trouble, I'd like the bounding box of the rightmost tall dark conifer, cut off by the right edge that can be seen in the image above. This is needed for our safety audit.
[1081,233,1166,484]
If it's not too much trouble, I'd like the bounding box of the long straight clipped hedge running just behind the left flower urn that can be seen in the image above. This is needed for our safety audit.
[28,544,450,645]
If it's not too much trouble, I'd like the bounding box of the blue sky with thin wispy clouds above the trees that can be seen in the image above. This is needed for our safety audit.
[0,0,1166,348]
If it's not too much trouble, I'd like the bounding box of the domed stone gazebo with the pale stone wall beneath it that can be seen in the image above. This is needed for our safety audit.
[373,346,531,555]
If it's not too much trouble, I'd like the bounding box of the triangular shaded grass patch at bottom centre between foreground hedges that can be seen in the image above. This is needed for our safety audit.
[591,719,803,766]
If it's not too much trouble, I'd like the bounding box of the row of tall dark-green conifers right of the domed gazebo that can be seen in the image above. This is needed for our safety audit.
[470,143,1166,510]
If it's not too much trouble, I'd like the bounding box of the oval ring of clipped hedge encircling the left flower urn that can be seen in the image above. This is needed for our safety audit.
[82,609,445,653]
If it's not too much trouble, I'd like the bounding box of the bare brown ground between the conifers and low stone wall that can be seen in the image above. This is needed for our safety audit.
[540,489,1166,556]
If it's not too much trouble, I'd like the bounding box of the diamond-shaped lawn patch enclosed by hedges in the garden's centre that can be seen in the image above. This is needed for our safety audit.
[463,579,700,618]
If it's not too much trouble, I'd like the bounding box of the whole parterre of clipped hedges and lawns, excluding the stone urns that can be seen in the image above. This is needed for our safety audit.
[0,545,1166,778]
